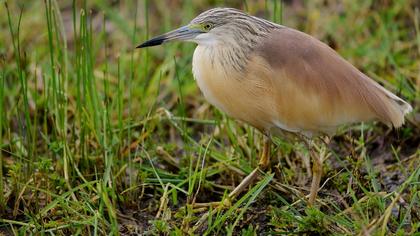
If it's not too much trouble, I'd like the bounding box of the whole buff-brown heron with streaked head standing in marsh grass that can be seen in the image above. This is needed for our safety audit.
[137,8,412,205]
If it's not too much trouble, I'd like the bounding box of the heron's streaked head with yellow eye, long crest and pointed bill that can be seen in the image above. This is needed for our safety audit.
[137,8,276,48]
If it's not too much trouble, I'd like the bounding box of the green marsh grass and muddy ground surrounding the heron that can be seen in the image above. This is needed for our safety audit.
[0,0,420,235]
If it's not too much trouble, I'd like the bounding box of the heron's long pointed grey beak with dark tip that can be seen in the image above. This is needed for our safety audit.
[136,25,203,48]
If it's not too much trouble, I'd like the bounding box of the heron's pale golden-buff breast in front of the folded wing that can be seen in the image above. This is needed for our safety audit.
[192,46,275,130]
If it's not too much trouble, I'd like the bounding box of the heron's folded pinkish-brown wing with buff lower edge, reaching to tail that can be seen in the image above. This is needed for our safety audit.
[256,27,411,132]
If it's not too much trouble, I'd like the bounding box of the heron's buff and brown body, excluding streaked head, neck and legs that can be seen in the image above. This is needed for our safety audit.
[193,27,412,136]
